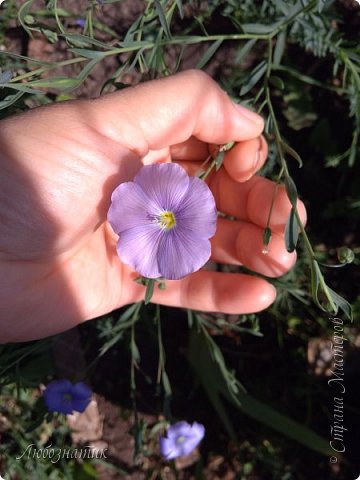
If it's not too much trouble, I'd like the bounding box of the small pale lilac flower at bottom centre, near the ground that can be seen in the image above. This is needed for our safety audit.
[160,422,205,460]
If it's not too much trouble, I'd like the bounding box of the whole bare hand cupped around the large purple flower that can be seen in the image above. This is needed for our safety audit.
[0,71,305,343]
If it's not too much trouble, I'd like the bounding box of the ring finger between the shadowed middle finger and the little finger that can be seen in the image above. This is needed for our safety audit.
[211,218,296,277]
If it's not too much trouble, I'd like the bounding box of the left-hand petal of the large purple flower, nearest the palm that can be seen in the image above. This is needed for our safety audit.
[108,182,159,234]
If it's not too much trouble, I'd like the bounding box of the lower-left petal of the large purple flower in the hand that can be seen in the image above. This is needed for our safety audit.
[117,223,163,278]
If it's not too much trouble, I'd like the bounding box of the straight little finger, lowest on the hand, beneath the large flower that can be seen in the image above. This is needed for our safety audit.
[143,270,276,314]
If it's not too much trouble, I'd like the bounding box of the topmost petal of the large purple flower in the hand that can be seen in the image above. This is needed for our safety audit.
[134,163,189,211]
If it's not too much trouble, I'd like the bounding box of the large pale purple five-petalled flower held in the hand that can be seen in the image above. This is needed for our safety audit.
[108,163,217,280]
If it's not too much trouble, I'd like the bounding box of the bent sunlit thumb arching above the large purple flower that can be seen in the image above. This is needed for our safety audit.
[87,70,264,156]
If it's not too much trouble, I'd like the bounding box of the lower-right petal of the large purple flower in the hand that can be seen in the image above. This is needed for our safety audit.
[157,226,211,280]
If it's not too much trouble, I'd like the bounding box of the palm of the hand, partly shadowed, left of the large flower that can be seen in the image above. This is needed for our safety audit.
[0,104,146,338]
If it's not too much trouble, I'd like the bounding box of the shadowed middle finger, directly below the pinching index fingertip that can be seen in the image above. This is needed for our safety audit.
[209,169,306,234]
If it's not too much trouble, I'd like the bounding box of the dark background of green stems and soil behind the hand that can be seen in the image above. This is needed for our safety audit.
[0,0,360,480]
